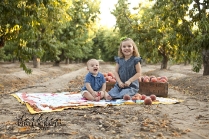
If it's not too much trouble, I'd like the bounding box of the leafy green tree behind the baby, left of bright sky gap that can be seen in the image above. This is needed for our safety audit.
[56,0,99,64]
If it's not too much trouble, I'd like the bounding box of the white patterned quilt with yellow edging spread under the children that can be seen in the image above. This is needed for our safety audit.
[12,92,181,114]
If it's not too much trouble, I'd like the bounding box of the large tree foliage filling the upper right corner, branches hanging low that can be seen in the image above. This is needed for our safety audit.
[153,0,209,75]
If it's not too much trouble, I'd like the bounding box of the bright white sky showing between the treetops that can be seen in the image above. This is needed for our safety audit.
[100,0,140,27]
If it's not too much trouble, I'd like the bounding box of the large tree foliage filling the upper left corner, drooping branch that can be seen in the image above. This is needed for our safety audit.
[0,0,62,73]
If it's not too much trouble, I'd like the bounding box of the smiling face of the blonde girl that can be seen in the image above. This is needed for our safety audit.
[121,41,134,58]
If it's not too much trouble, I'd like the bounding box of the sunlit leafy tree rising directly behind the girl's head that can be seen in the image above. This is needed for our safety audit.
[112,0,157,62]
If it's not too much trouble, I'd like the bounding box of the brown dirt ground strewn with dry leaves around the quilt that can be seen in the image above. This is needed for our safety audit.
[0,63,209,139]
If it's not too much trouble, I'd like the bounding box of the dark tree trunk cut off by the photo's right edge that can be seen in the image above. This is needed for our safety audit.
[202,49,209,76]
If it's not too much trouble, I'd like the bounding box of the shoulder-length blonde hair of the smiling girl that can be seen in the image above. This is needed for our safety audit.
[118,38,140,58]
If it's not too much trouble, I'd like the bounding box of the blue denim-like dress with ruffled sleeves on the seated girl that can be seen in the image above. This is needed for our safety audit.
[108,56,141,99]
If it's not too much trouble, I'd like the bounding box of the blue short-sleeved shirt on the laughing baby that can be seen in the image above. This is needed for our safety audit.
[81,72,106,91]
